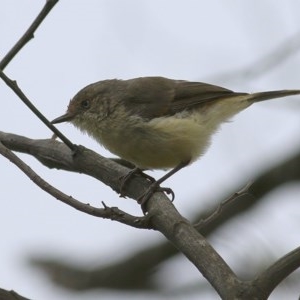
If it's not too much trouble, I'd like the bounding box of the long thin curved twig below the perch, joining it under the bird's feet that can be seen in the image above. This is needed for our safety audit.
[0,142,152,229]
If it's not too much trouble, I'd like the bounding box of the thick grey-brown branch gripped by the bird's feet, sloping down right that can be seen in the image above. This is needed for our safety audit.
[0,132,239,299]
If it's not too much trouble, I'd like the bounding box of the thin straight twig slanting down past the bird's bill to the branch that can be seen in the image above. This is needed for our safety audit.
[0,70,76,151]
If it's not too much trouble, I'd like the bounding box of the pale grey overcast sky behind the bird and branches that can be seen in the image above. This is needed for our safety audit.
[0,0,300,300]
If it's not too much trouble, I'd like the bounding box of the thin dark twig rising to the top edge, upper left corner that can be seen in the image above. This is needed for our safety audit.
[0,0,58,70]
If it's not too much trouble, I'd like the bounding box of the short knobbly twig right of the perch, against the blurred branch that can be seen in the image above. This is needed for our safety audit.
[194,181,253,231]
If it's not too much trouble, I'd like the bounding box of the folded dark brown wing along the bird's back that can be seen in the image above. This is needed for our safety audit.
[124,77,245,119]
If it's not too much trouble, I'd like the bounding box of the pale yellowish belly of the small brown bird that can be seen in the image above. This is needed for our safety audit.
[101,117,211,169]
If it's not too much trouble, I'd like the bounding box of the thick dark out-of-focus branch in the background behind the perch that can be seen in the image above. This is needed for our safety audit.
[42,146,300,290]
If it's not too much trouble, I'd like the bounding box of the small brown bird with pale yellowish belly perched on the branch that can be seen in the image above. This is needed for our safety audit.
[52,77,300,206]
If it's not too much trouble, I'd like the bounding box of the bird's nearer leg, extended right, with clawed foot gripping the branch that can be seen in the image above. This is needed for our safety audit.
[138,160,190,213]
